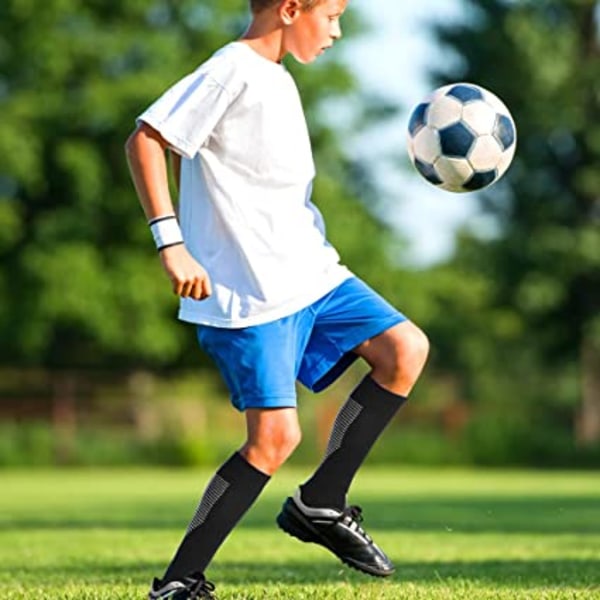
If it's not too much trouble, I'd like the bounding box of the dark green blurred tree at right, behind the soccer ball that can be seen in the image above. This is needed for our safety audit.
[426,0,600,445]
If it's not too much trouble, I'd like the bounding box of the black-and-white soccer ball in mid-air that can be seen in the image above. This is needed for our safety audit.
[408,83,517,192]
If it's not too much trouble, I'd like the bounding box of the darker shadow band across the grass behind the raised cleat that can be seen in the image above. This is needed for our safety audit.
[0,496,600,535]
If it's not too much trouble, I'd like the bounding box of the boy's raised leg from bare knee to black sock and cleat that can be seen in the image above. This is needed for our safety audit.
[277,321,429,576]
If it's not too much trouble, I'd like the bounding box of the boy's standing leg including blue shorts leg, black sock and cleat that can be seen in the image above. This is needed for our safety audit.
[150,310,304,600]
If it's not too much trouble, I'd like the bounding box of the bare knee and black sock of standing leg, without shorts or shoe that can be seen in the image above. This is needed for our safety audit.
[158,408,300,584]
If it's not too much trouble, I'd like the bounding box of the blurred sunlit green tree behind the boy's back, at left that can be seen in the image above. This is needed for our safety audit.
[0,0,404,370]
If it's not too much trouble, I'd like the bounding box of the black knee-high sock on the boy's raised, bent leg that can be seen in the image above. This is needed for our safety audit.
[300,376,406,510]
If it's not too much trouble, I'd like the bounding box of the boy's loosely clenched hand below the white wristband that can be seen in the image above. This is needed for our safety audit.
[159,244,212,300]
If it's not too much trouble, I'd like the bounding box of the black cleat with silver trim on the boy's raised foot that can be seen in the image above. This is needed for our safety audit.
[277,490,395,577]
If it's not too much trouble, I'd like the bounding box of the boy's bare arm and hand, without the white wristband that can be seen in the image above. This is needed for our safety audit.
[125,123,211,300]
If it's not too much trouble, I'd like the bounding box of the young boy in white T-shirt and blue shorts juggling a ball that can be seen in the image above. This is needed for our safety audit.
[126,0,428,600]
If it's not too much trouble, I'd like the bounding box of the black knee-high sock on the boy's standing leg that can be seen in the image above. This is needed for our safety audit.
[163,452,270,582]
